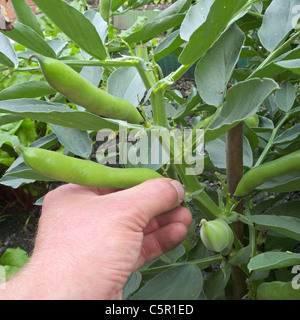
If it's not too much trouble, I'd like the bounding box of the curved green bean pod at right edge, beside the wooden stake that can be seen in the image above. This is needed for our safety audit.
[234,150,300,197]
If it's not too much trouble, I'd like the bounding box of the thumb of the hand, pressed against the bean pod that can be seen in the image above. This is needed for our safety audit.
[107,178,184,229]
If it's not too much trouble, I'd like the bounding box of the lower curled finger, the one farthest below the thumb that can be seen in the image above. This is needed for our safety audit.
[136,222,187,269]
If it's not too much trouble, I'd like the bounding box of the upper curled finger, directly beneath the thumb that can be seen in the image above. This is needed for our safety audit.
[144,207,192,235]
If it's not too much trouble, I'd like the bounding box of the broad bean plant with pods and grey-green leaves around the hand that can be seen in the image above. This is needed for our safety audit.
[0,0,300,300]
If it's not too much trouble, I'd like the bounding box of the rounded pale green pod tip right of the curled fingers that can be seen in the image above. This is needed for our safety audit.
[200,219,234,255]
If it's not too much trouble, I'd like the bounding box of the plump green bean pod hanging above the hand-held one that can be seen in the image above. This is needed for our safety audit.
[33,55,144,124]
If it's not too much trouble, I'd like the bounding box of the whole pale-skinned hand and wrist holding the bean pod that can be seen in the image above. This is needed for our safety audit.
[0,179,192,300]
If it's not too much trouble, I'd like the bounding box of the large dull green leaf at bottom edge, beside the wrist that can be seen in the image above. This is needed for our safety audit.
[131,264,203,300]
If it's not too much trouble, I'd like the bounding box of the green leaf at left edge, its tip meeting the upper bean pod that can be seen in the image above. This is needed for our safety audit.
[0,80,56,101]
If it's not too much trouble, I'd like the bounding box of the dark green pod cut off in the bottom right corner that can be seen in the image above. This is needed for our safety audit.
[256,281,300,300]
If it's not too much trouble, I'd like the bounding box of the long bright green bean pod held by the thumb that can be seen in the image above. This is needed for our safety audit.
[19,146,162,189]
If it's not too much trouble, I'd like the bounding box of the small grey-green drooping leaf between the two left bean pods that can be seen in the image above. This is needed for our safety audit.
[50,124,93,158]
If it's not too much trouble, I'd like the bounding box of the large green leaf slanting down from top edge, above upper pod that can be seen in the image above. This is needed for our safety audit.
[34,0,107,60]
